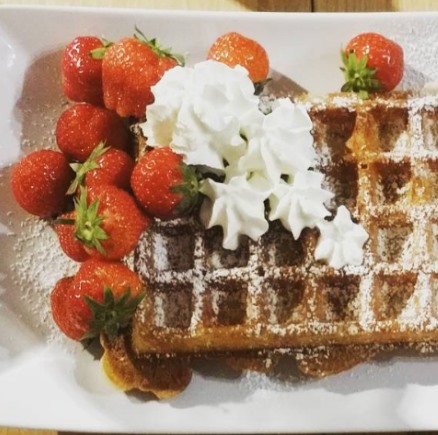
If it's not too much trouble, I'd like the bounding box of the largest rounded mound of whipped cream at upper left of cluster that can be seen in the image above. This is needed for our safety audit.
[141,60,260,171]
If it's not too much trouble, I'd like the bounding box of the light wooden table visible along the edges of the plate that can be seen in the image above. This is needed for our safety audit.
[0,0,438,435]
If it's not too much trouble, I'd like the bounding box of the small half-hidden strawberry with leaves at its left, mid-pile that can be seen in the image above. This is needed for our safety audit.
[69,142,134,193]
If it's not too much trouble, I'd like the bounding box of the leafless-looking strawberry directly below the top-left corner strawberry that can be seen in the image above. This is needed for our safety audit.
[56,103,130,162]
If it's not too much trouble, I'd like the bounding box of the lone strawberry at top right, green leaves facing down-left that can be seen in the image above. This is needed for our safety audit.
[341,32,404,98]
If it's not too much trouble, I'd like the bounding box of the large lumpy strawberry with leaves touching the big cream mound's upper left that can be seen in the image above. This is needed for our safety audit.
[102,29,183,118]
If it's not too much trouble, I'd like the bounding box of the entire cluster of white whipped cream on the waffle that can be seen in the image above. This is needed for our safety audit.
[141,60,368,268]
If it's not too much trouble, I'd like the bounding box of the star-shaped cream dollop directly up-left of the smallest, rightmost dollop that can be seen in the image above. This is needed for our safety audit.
[269,171,333,240]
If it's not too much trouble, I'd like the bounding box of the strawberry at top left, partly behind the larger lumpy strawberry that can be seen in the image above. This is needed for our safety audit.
[61,36,105,105]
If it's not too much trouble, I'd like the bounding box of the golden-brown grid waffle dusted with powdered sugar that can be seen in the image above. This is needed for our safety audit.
[102,93,438,396]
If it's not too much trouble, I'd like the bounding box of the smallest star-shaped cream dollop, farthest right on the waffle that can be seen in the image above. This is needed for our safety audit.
[315,205,369,269]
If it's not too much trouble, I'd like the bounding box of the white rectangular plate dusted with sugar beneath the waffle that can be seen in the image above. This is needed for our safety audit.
[0,7,438,433]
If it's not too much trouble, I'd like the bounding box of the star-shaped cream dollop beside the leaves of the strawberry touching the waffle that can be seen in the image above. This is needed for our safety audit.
[200,176,269,250]
